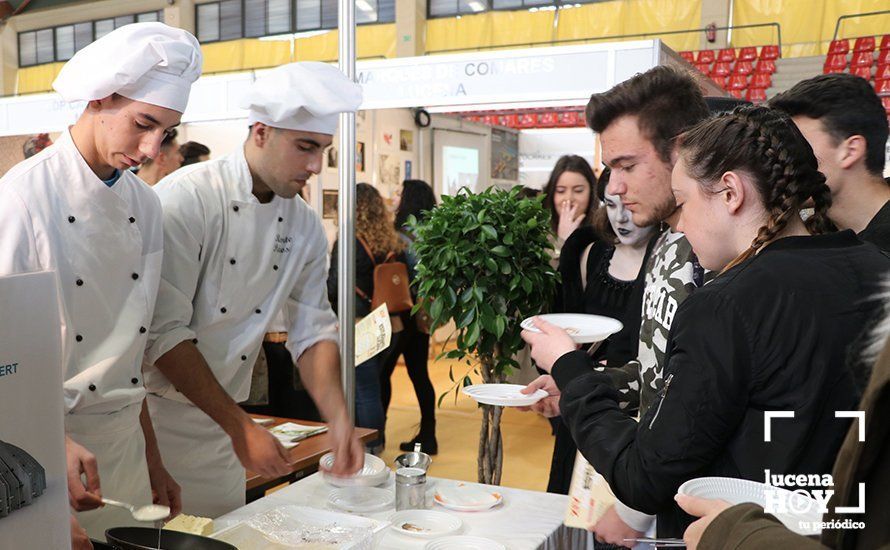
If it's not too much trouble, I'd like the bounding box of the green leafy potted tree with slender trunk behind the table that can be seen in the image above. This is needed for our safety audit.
[409,186,558,484]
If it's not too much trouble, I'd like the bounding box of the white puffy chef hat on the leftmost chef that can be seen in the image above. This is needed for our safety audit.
[53,23,203,113]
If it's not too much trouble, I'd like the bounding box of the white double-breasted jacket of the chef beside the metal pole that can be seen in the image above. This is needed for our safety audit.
[146,149,337,402]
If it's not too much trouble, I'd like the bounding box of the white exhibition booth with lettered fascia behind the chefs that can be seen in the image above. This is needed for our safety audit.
[0,40,722,226]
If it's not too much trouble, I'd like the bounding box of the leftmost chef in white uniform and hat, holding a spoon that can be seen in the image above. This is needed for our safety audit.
[0,23,201,540]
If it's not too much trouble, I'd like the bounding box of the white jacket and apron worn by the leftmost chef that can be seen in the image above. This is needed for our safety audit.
[0,131,163,540]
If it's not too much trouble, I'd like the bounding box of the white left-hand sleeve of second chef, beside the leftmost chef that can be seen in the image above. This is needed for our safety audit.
[145,185,204,364]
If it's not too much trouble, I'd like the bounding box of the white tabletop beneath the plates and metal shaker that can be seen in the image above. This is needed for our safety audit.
[213,474,593,550]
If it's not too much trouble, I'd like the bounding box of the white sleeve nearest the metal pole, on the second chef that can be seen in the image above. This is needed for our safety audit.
[287,233,338,361]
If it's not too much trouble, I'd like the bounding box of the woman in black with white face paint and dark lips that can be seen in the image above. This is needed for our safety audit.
[547,168,656,494]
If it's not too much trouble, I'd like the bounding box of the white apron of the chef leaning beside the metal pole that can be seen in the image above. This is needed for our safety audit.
[146,394,247,518]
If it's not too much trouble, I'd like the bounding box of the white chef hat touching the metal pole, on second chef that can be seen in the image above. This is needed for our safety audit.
[241,61,362,135]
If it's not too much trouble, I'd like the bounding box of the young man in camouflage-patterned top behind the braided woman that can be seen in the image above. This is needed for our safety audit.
[526,66,708,545]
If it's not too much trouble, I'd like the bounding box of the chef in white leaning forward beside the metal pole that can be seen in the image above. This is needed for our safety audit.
[146,63,364,517]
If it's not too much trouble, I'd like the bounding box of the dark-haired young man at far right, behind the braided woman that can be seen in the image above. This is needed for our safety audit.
[769,73,890,250]
